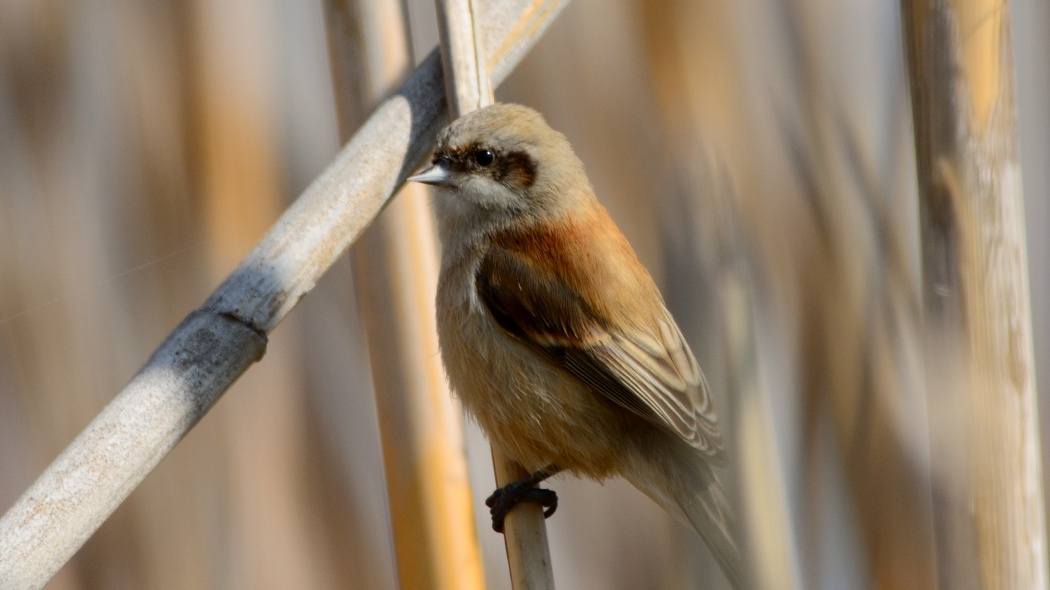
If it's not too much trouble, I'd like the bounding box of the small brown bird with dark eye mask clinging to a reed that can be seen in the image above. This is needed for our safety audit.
[408,104,742,588]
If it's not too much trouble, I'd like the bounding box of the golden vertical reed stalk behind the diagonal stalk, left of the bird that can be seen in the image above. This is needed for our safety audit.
[326,0,484,590]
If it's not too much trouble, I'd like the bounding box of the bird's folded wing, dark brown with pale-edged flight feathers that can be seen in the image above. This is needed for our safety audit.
[475,239,722,463]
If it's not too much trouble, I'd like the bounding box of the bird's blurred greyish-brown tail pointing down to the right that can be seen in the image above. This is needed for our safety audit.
[624,434,746,590]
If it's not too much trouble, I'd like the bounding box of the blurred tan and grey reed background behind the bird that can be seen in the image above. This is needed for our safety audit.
[0,0,1050,590]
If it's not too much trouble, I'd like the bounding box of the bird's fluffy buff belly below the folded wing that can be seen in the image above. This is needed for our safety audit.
[438,289,627,478]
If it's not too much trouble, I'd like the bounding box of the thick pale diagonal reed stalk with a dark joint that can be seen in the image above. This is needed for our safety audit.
[0,0,566,589]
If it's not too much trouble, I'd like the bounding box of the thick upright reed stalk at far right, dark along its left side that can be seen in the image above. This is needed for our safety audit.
[901,0,1047,590]
